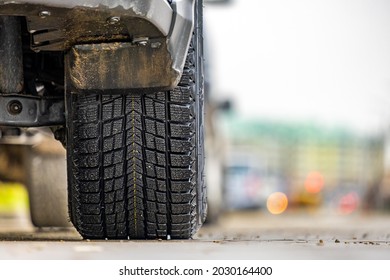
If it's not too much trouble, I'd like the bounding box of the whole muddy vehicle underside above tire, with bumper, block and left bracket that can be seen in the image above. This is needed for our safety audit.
[0,0,195,127]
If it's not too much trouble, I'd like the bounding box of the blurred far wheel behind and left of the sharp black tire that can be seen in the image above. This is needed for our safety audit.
[24,133,72,227]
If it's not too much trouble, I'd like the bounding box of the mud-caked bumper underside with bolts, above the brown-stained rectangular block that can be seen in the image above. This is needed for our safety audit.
[0,0,172,51]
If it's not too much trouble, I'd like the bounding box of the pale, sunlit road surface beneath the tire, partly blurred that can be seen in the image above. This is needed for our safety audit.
[0,210,390,260]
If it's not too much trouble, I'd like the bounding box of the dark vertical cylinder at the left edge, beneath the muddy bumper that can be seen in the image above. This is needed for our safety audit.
[0,16,23,93]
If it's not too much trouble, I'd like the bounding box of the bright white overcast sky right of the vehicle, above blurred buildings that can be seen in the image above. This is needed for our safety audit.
[205,0,390,136]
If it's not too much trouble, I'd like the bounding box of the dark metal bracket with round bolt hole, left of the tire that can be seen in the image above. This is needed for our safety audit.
[0,94,65,127]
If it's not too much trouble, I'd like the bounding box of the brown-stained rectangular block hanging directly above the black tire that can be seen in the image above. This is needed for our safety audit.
[66,41,180,90]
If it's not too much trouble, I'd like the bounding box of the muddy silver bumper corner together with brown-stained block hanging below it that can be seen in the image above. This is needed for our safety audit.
[0,0,196,91]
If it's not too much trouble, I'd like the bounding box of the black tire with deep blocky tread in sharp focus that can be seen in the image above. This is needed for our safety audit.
[67,2,206,239]
